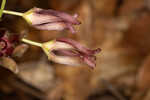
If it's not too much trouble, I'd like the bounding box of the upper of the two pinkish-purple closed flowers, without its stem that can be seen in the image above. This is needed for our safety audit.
[23,8,80,33]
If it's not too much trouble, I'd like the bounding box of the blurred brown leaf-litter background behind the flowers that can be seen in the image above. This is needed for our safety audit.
[0,0,150,100]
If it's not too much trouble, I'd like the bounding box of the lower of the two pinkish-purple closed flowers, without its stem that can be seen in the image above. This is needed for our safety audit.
[42,38,101,68]
